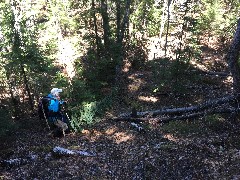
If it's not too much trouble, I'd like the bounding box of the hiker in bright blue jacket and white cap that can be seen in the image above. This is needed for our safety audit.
[47,88,68,131]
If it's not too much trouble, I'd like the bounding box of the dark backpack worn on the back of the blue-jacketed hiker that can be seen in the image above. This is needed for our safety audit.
[38,96,53,119]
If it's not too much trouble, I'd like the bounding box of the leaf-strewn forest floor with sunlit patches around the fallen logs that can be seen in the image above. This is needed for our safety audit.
[0,40,240,180]
